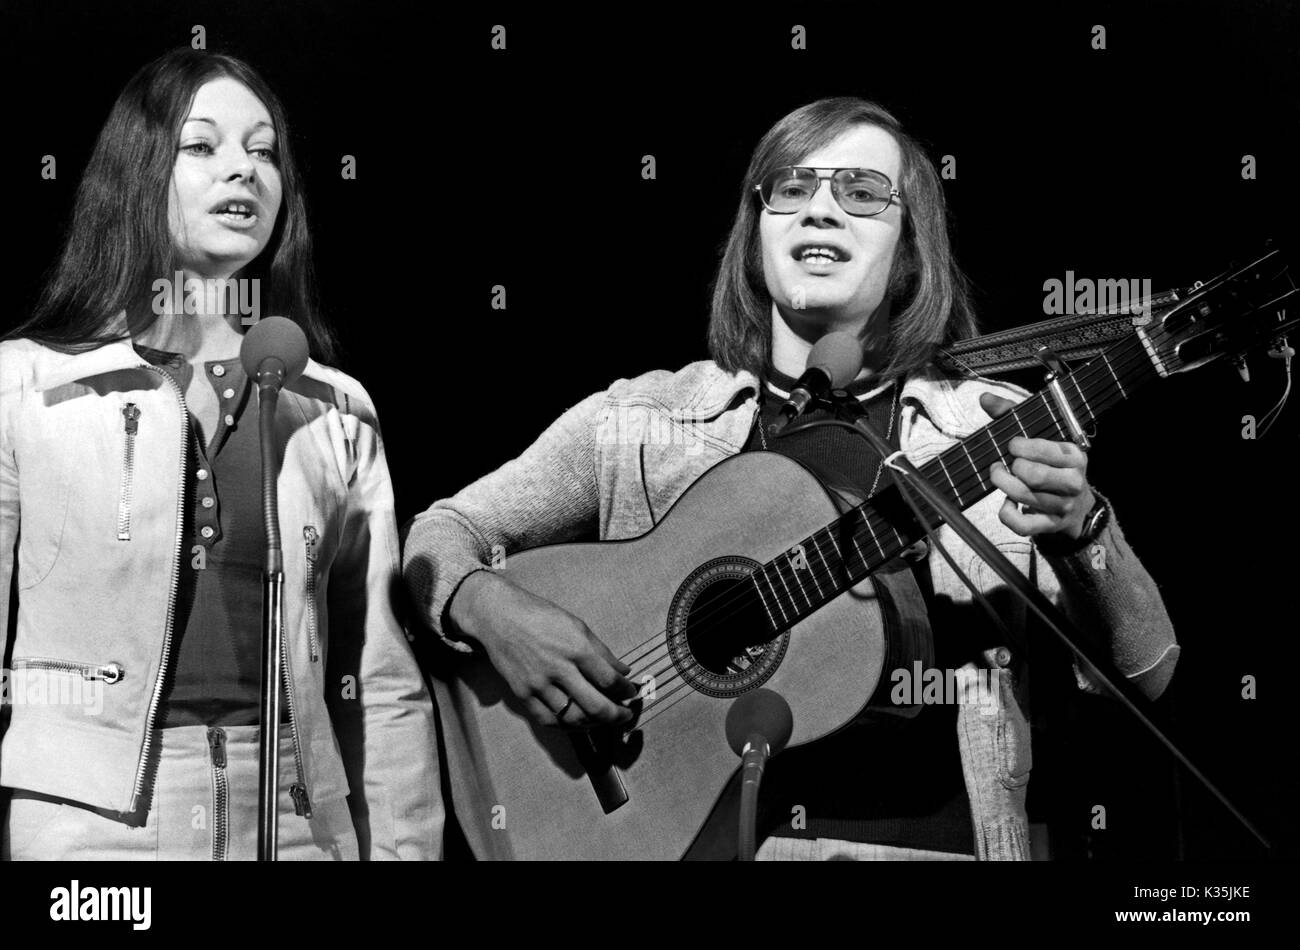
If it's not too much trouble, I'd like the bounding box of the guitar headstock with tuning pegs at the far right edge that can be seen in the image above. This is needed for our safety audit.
[1135,246,1300,376]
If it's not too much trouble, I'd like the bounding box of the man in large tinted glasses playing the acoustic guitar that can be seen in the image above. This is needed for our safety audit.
[404,97,1178,859]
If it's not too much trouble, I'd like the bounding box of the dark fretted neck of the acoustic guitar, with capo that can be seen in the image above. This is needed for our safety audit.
[751,330,1164,633]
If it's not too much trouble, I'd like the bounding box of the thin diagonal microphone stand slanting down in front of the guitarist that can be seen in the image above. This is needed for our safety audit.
[836,403,1271,849]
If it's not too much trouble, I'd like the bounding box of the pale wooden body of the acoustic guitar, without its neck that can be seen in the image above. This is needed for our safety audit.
[434,452,904,860]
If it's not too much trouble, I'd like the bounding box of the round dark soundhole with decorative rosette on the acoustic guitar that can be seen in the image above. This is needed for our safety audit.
[668,556,789,697]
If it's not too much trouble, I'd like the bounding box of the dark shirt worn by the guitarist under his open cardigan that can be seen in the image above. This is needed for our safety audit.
[745,369,975,854]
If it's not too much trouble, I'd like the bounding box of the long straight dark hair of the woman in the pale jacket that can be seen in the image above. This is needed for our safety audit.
[5,48,337,363]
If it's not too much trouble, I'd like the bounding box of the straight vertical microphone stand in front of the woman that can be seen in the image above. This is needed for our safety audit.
[257,359,285,860]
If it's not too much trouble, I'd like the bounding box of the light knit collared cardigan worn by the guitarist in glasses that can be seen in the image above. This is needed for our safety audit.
[403,361,1179,859]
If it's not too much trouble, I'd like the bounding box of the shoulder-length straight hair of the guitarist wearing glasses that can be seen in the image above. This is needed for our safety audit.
[709,96,978,378]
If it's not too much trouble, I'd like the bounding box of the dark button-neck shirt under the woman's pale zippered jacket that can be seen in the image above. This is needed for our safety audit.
[135,344,276,728]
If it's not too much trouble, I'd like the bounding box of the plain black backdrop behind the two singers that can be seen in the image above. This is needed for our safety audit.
[0,0,1300,859]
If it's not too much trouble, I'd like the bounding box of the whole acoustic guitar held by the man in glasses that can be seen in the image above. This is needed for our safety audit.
[434,250,1297,859]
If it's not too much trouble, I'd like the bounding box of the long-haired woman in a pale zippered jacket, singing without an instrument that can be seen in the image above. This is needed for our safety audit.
[0,49,442,860]
